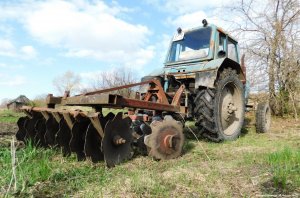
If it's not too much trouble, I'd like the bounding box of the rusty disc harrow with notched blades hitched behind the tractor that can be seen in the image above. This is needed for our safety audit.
[16,80,185,167]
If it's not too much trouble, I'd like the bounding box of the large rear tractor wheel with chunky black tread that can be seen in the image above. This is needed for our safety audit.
[194,68,245,142]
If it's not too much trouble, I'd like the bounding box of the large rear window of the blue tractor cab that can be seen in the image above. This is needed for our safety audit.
[167,27,211,62]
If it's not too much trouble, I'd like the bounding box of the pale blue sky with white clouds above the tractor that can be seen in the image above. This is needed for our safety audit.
[0,0,236,101]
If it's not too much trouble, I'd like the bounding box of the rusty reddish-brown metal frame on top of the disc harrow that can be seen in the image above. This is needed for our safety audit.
[41,76,184,115]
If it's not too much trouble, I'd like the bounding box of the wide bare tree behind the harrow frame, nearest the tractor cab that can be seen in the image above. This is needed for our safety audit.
[92,68,137,97]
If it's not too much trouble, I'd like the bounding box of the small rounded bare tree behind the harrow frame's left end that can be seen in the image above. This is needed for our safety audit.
[53,71,81,95]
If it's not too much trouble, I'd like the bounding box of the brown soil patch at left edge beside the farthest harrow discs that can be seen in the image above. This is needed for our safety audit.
[0,122,18,148]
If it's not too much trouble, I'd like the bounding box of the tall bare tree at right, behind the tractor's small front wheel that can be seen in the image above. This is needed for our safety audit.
[227,0,300,118]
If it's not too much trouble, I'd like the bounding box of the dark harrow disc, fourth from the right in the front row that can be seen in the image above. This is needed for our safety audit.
[55,119,71,157]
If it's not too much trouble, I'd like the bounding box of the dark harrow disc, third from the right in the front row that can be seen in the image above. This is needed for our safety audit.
[70,118,91,161]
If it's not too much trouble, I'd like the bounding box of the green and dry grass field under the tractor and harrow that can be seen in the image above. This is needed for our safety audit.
[0,109,300,197]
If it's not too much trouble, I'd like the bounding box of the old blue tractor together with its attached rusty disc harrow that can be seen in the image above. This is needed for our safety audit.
[16,20,271,167]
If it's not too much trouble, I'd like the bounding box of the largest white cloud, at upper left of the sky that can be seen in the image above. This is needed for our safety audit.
[0,0,154,65]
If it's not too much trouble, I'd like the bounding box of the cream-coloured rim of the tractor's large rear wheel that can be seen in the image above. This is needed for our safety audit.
[220,82,243,136]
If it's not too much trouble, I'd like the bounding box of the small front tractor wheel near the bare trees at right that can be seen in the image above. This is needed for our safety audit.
[255,102,271,133]
